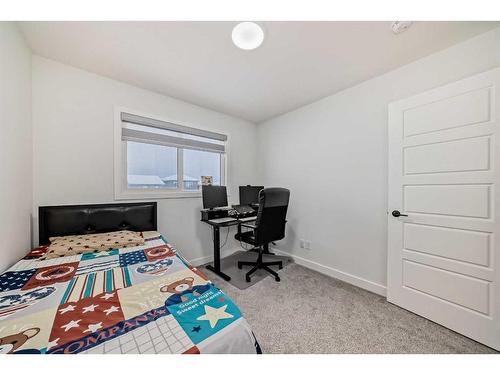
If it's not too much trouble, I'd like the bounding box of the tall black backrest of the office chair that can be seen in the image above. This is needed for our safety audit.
[254,188,290,245]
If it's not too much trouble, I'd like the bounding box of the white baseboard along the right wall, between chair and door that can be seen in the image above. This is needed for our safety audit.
[272,248,387,297]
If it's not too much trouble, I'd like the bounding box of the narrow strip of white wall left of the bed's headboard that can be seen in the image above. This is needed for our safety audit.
[0,22,33,273]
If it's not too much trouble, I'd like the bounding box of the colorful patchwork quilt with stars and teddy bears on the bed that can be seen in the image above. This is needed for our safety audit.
[0,232,260,354]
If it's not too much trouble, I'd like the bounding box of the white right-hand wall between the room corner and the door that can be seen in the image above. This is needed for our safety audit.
[258,29,500,293]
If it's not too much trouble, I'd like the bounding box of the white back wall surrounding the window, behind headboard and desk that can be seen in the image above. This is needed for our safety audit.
[33,56,257,261]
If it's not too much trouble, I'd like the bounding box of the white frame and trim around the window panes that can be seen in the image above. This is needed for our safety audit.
[113,106,230,200]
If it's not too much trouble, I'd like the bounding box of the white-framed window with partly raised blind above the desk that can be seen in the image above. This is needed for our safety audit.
[115,112,227,199]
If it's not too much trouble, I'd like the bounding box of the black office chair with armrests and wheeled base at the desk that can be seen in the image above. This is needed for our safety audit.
[235,188,290,282]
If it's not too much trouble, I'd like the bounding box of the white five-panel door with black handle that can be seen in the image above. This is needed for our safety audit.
[387,69,500,350]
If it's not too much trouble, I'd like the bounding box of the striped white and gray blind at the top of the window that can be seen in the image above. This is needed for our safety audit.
[121,112,227,153]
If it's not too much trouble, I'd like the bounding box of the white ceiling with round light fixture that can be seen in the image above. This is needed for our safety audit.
[19,21,500,123]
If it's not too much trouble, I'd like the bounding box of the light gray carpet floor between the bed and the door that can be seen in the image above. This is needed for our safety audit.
[205,263,496,353]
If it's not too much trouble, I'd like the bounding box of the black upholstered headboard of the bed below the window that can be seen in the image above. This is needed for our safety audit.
[38,202,157,245]
